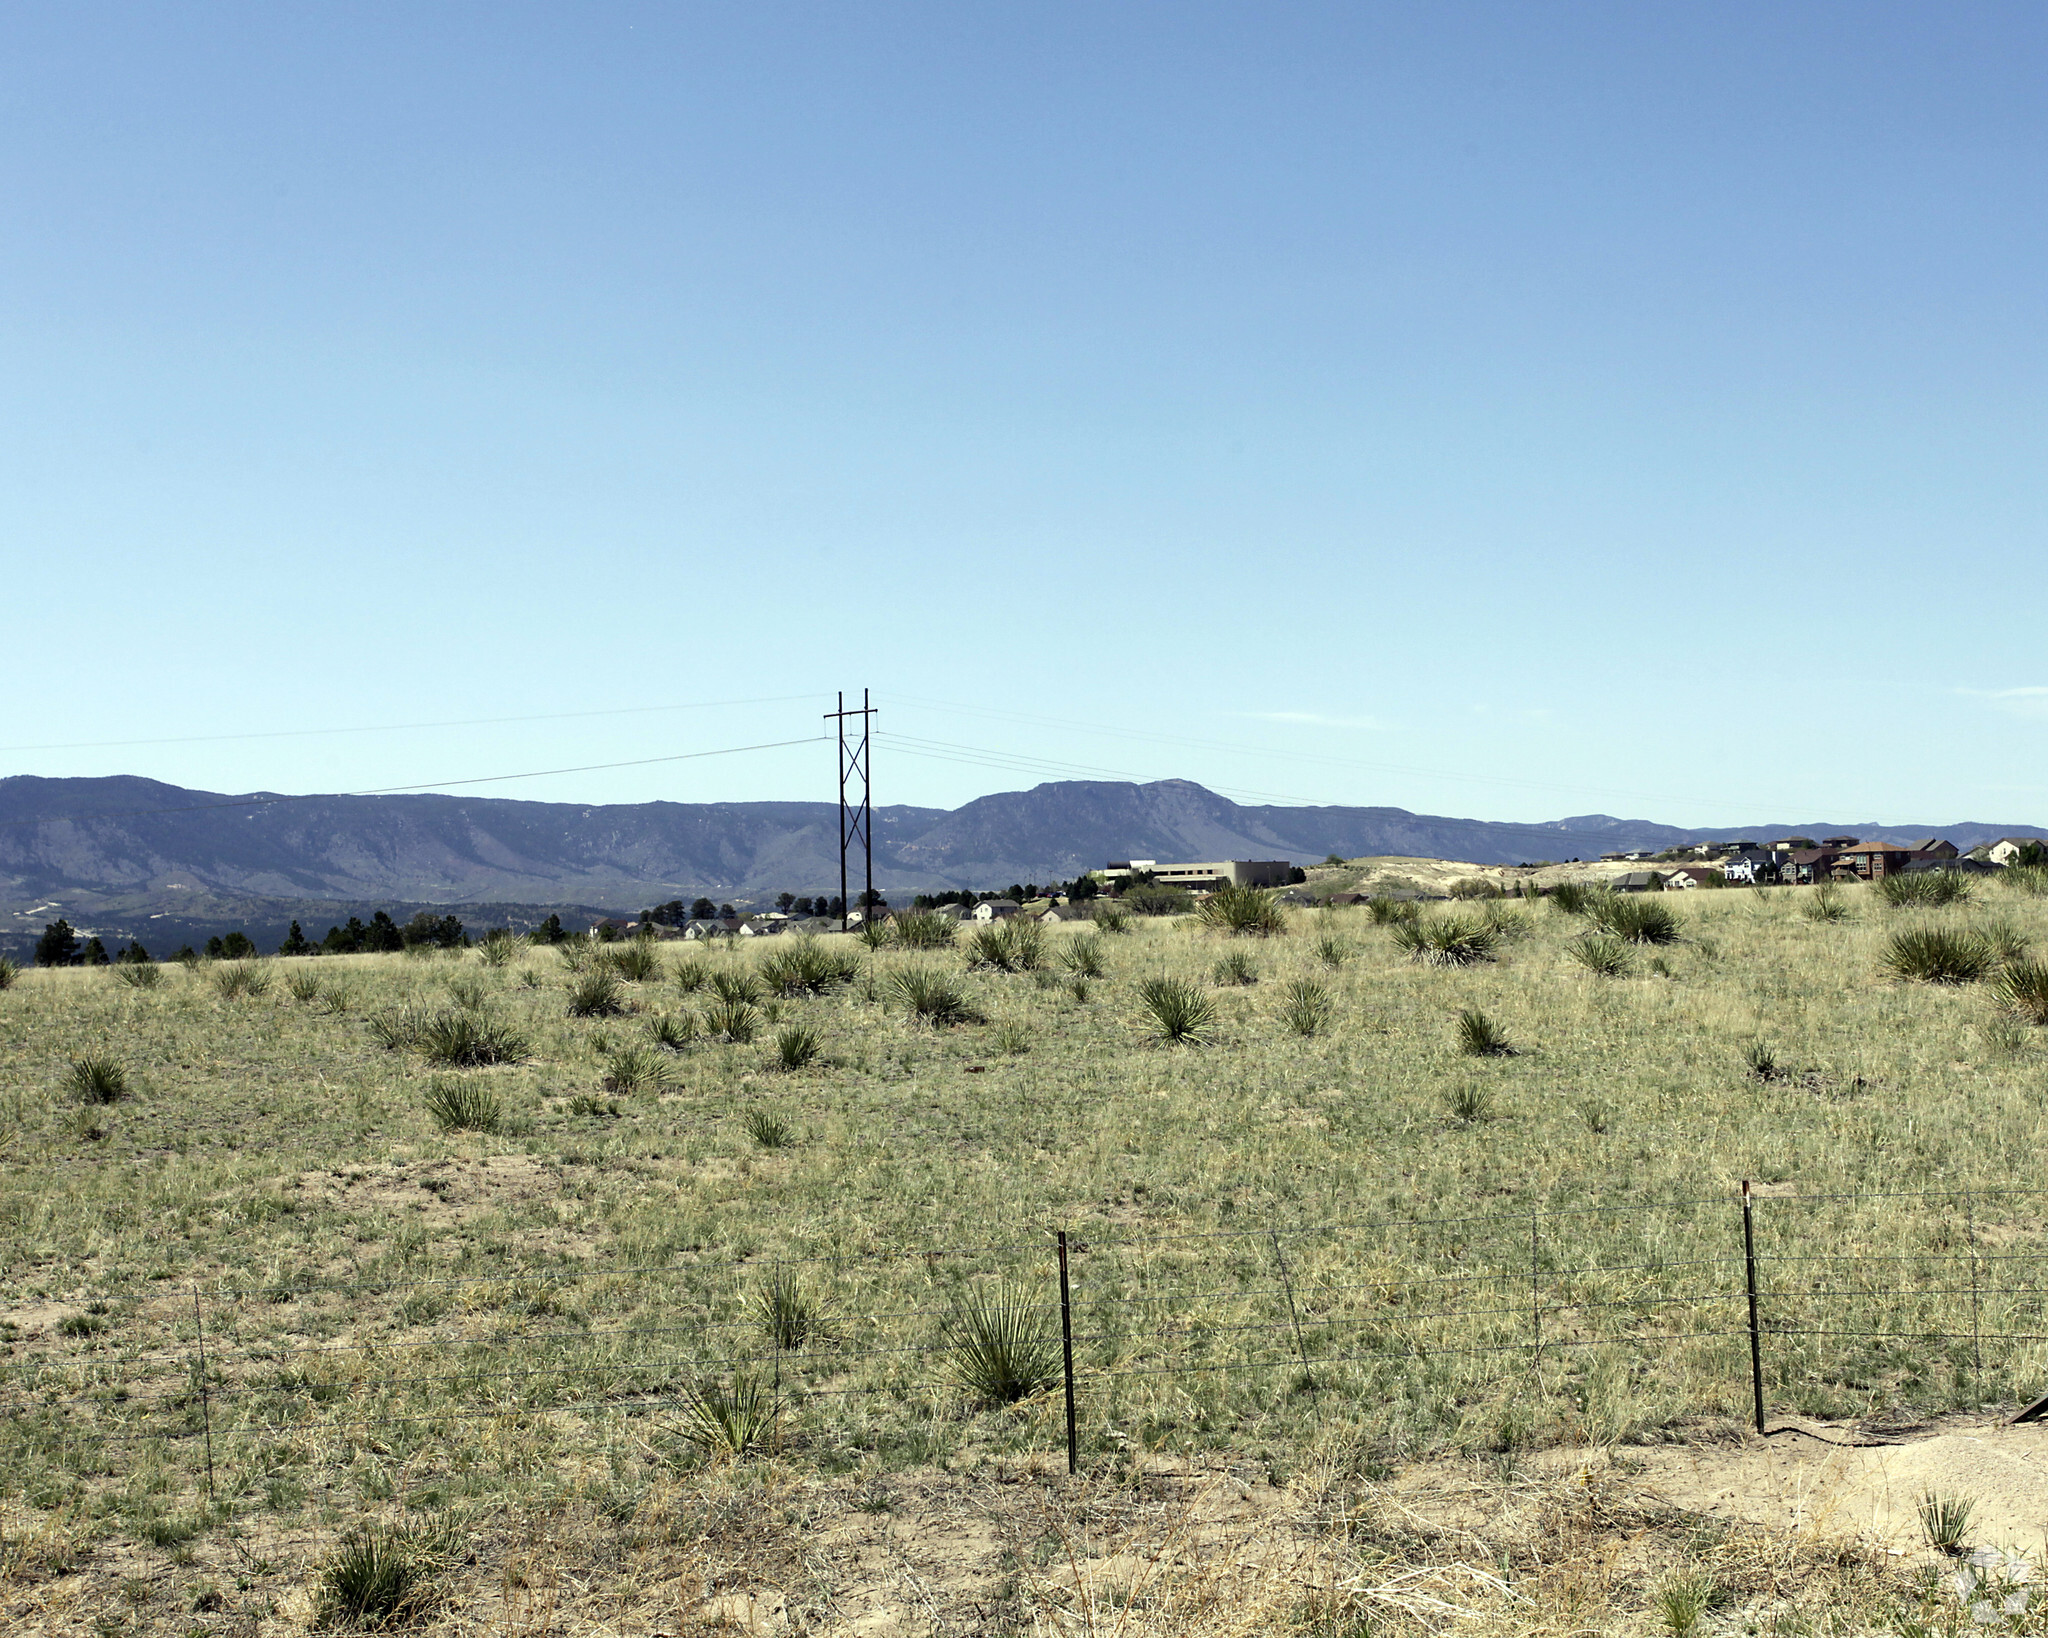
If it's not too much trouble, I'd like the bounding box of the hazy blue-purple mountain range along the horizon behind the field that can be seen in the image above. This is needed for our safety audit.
[0,776,2036,944]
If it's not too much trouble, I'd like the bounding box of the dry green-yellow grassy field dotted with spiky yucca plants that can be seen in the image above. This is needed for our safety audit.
[0,882,2048,1634]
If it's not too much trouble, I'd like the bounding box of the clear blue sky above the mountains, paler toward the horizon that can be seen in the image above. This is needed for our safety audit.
[0,4,2048,825]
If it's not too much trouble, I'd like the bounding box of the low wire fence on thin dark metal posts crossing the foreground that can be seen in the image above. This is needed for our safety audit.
[0,1186,2048,1482]
